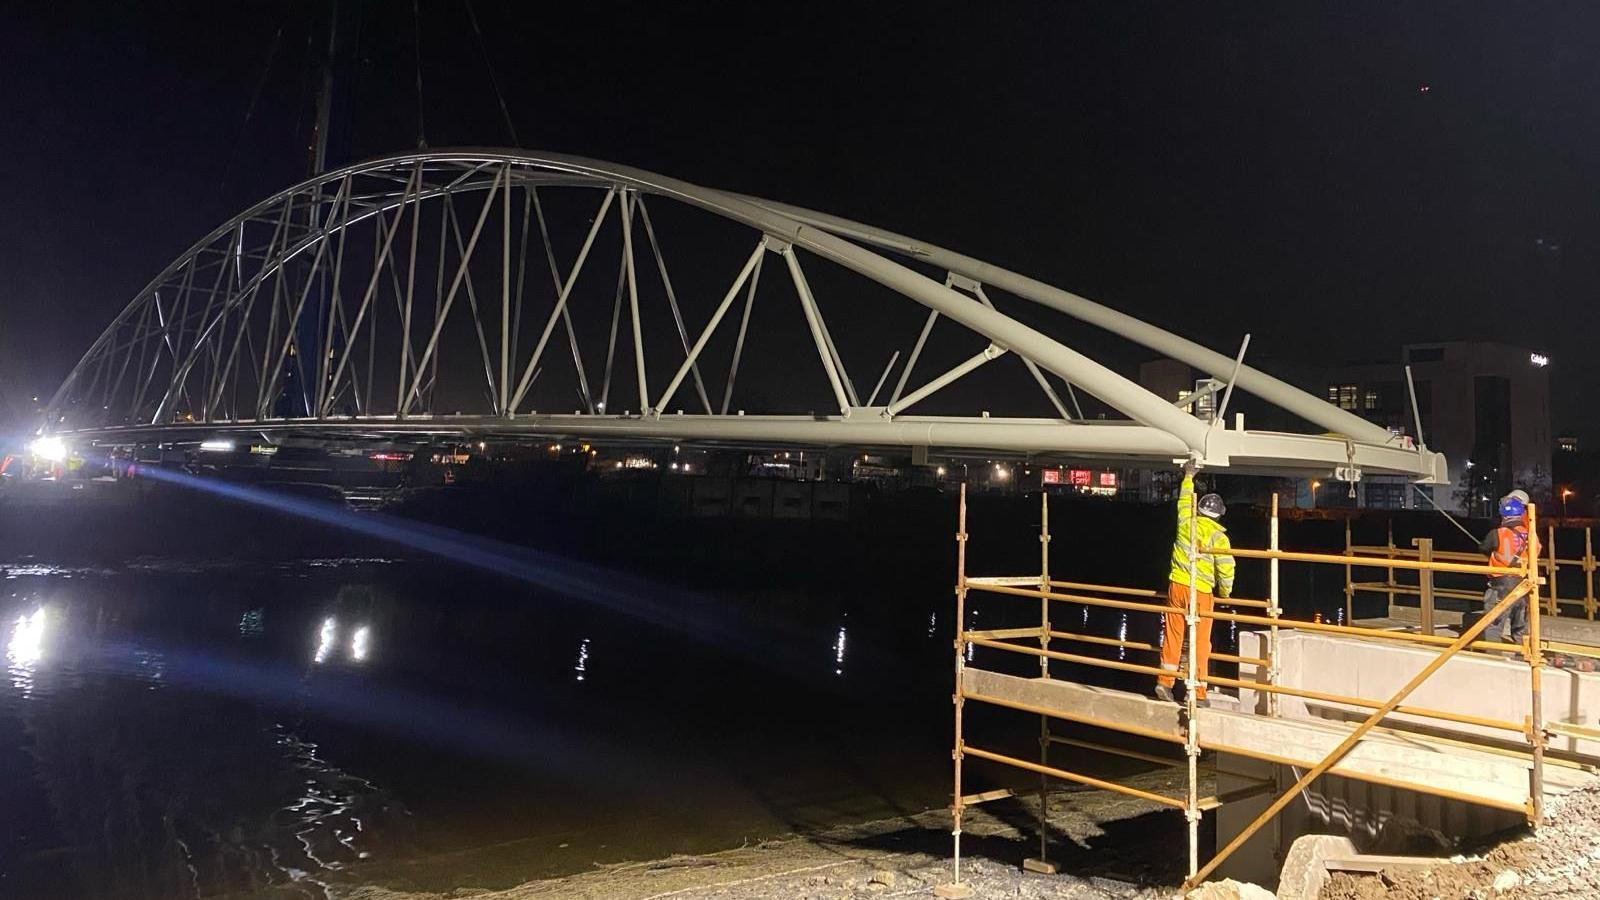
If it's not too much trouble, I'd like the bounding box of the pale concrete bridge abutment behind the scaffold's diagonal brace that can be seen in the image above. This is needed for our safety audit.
[1202,629,1600,884]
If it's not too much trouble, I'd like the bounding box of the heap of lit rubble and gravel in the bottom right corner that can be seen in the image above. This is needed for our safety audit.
[1320,786,1600,900]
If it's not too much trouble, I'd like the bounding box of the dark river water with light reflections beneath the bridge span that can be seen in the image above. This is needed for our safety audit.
[0,483,1420,900]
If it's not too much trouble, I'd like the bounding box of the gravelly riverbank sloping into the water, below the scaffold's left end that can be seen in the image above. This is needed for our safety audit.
[338,770,1210,900]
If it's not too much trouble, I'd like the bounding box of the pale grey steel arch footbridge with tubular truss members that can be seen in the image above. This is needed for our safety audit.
[43,149,1448,484]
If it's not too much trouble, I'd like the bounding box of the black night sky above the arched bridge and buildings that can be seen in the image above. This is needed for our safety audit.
[0,0,1600,440]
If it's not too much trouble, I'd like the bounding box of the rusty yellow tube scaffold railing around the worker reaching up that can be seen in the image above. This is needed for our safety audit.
[952,485,1555,884]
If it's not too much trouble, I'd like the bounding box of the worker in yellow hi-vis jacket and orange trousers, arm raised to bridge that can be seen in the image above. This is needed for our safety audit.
[1155,464,1234,705]
